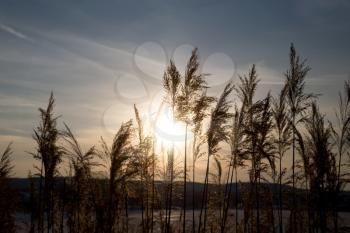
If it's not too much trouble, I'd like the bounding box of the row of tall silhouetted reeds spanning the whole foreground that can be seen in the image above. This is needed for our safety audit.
[0,45,350,233]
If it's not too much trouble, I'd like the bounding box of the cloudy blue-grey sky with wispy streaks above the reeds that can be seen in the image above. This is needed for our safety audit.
[0,0,350,177]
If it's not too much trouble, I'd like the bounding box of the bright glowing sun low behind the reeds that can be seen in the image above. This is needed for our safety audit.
[154,107,185,146]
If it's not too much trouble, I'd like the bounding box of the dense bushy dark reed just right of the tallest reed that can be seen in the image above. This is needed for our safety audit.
[305,102,337,233]
